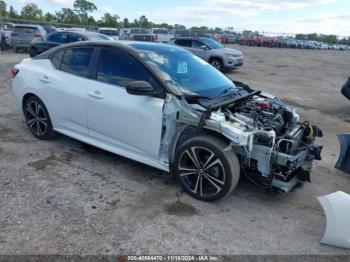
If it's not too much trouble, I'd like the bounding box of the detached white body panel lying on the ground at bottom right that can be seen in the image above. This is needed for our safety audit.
[317,191,350,249]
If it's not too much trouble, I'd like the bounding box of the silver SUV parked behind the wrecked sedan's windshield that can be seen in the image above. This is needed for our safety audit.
[169,37,244,71]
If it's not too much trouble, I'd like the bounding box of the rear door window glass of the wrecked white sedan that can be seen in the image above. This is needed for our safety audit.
[61,47,94,77]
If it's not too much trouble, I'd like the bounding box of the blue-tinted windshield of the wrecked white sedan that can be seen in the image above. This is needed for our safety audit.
[131,43,236,98]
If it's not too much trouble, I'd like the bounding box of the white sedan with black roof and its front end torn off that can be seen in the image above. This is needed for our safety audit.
[12,42,322,201]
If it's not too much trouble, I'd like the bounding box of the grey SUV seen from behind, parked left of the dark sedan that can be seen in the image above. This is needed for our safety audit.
[11,25,46,53]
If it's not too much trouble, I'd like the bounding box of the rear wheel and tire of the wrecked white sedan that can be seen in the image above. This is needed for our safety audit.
[23,96,56,140]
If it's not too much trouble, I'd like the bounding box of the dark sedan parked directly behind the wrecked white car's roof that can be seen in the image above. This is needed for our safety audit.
[29,31,113,57]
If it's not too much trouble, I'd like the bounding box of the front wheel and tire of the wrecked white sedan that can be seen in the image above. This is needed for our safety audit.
[173,136,240,201]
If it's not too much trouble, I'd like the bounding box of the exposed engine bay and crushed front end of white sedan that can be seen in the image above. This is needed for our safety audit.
[172,83,322,192]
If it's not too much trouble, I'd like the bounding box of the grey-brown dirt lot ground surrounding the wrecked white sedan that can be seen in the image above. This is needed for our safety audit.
[0,47,350,254]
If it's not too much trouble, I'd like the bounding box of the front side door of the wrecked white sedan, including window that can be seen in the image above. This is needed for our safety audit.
[87,48,164,159]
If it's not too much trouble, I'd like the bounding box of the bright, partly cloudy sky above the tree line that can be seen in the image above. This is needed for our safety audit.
[5,0,350,36]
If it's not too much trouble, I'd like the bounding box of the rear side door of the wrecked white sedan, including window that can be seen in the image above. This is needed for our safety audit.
[40,47,94,135]
